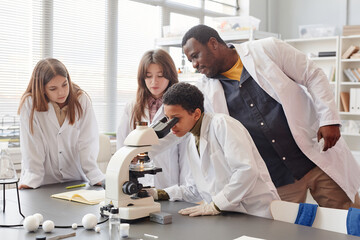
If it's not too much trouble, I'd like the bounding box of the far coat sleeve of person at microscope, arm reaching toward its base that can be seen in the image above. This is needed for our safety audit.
[164,135,202,203]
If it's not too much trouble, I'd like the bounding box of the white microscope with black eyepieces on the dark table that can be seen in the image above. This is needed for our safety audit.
[101,117,179,221]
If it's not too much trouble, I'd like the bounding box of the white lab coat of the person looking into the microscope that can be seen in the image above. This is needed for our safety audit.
[176,113,280,218]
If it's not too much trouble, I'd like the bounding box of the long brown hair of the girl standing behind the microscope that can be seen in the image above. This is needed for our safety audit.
[132,49,179,127]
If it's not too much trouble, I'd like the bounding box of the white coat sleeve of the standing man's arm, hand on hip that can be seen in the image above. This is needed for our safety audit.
[269,38,341,126]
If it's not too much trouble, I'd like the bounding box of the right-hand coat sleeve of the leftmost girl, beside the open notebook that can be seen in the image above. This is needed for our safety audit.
[78,94,105,185]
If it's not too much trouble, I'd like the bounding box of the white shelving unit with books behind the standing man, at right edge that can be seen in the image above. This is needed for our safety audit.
[285,36,360,155]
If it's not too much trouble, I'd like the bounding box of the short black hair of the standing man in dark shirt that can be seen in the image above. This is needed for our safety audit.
[181,24,226,47]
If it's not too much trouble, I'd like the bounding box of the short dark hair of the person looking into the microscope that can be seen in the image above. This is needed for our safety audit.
[163,82,204,113]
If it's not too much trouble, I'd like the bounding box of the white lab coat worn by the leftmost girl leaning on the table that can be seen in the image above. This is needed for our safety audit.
[20,94,105,188]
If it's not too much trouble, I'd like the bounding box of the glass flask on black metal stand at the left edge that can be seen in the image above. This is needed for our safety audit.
[0,142,25,218]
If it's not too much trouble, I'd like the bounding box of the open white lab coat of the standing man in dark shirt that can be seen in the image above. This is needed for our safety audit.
[198,38,360,201]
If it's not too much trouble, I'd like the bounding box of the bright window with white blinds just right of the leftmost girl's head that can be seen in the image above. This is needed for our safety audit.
[53,0,106,131]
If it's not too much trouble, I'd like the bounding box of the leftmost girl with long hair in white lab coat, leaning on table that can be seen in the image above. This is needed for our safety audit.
[18,58,104,189]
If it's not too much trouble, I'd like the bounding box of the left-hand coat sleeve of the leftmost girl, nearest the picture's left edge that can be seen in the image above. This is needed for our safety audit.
[20,98,46,188]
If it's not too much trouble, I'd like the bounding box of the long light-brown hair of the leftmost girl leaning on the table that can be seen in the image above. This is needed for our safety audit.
[18,58,83,133]
